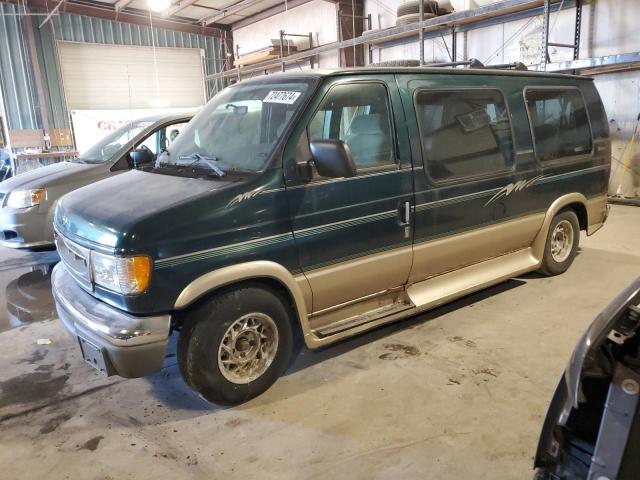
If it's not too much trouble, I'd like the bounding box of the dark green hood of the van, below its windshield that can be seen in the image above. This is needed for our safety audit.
[54,170,238,253]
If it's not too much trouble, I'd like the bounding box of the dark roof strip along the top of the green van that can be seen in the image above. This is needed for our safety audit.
[243,65,593,82]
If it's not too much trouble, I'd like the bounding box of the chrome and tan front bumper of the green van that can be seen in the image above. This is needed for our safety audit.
[51,264,171,378]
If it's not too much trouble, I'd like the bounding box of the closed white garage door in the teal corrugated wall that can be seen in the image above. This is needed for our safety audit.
[58,42,205,110]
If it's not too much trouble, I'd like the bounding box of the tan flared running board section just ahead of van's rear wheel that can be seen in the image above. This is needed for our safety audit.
[407,248,540,310]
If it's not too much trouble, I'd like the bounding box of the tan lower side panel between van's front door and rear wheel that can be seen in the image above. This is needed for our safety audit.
[409,213,545,283]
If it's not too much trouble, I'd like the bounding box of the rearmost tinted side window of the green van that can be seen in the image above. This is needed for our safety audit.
[525,89,591,162]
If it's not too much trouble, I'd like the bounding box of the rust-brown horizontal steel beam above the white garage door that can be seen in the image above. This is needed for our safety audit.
[3,0,225,38]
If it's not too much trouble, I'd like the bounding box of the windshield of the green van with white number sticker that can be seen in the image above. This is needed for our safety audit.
[154,80,309,177]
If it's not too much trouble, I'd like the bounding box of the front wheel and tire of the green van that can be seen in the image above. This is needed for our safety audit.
[178,284,294,405]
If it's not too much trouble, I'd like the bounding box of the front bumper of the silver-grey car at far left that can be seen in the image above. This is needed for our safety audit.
[0,206,53,248]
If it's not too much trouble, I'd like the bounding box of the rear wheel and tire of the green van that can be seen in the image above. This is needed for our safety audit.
[539,210,580,276]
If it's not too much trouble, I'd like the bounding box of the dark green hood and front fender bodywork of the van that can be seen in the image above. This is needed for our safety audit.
[56,171,299,314]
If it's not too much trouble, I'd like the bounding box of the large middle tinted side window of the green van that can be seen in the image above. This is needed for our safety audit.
[415,90,513,182]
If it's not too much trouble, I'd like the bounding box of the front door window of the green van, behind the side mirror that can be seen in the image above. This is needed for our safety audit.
[307,83,395,169]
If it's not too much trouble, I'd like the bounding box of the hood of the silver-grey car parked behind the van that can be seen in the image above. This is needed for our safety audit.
[0,162,109,193]
